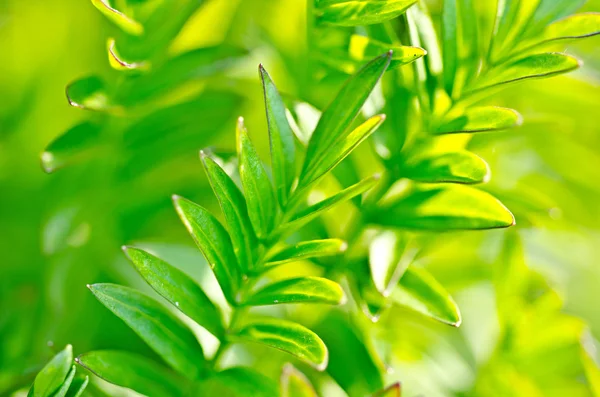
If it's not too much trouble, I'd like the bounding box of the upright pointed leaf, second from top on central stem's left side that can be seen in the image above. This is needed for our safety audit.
[237,117,277,238]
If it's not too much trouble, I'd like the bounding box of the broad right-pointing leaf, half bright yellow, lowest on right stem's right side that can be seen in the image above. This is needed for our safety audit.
[371,185,515,230]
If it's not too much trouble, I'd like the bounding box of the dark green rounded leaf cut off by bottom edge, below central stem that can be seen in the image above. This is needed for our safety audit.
[198,367,279,397]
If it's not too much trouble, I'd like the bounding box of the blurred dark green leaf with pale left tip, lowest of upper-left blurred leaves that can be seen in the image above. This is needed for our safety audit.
[41,122,101,173]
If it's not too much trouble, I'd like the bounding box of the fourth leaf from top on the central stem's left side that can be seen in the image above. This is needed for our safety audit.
[173,196,240,304]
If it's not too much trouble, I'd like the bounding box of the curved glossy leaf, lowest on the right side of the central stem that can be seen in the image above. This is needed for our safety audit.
[235,318,328,371]
